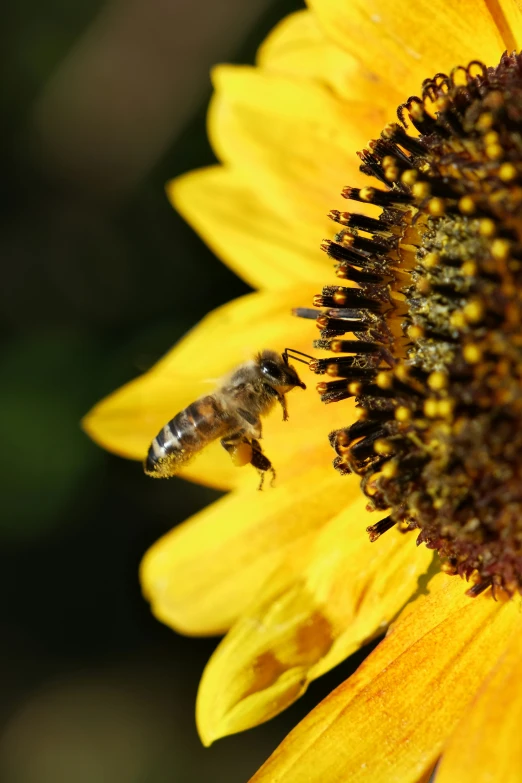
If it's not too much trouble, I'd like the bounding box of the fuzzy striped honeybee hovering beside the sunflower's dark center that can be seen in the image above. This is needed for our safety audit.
[144,348,308,489]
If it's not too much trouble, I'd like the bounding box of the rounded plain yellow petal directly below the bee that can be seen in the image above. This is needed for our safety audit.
[141,467,359,634]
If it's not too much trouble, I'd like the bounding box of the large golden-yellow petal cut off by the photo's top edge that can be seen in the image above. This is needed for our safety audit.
[308,0,506,101]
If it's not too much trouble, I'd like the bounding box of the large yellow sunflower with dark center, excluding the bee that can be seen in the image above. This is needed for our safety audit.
[85,0,522,783]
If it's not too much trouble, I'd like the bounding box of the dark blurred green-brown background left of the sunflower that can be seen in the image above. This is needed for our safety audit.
[0,0,372,783]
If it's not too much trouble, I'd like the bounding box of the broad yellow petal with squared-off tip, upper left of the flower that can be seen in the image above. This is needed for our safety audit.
[208,66,383,220]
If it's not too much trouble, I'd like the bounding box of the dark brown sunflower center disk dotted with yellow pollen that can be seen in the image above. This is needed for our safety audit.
[310,54,522,595]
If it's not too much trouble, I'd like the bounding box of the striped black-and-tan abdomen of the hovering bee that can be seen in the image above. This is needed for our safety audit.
[145,394,230,478]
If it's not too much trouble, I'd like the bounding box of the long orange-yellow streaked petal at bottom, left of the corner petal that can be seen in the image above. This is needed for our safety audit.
[253,575,520,783]
